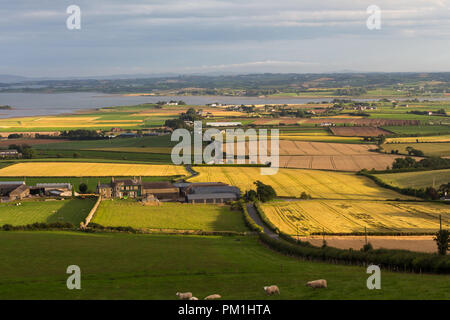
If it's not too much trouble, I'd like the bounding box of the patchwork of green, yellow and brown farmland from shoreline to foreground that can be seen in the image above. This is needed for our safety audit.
[0,84,450,299]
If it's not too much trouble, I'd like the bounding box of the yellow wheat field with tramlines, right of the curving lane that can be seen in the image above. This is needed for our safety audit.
[261,200,450,235]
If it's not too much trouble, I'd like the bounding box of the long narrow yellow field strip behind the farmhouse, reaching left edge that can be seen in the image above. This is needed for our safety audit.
[0,162,186,177]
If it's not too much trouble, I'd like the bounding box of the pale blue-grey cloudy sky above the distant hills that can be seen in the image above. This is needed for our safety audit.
[0,0,450,77]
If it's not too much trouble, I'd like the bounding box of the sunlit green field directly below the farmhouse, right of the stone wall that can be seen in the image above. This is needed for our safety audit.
[92,200,247,232]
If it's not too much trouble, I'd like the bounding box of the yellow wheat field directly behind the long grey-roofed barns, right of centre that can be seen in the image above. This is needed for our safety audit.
[188,166,410,199]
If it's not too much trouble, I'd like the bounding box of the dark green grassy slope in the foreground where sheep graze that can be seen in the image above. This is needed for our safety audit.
[0,232,450,299]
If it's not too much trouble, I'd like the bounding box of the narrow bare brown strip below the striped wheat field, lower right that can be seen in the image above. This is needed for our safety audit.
[300,236,437,252]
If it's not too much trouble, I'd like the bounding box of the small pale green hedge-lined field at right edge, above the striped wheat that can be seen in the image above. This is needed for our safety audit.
[375,169,450,189]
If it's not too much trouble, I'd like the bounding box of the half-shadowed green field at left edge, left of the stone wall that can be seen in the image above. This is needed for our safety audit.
[0,199,95,226]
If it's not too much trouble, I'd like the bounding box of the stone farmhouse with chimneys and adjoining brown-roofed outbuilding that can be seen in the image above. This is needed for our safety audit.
[97,177,179,200]
